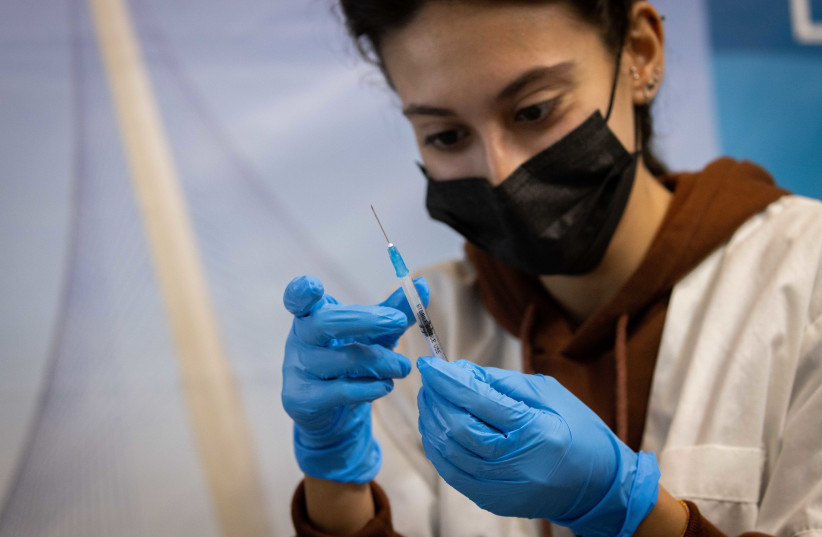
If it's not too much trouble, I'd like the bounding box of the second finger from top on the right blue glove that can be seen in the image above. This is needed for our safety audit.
[417,387,521,459]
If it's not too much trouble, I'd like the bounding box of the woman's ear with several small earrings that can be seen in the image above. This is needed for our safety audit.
[624,1,665,105]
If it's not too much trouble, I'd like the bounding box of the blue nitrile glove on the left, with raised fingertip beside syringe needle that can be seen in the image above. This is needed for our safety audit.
[282,276,428,483]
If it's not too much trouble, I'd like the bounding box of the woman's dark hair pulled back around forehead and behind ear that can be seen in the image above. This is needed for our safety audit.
[340,0,667,176]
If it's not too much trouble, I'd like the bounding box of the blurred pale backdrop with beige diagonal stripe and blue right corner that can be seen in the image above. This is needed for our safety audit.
[0,0,822,537]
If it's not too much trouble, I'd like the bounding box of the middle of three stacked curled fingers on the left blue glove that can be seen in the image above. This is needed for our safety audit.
[296,342,411,380]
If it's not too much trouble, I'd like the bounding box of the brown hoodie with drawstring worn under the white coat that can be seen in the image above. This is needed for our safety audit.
[292,158,787,537]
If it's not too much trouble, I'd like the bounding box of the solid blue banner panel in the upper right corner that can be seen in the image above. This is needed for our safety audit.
[706,0,822,198]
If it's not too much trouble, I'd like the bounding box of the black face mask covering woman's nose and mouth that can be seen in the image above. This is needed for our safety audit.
[421,53,638,275]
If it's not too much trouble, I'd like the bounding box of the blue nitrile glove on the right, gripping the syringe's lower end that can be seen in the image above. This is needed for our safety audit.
[417,357,660,537]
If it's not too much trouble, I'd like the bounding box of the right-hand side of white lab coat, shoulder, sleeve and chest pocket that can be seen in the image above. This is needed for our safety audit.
[643,197,822,537]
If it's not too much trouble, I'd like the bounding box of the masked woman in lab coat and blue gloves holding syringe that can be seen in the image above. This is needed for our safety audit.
[283,0,822,537]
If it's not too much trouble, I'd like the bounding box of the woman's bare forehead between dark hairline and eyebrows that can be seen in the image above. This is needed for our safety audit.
[381,1,607,101]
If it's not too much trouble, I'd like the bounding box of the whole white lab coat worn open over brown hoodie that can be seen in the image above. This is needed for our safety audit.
[374,196,822,537]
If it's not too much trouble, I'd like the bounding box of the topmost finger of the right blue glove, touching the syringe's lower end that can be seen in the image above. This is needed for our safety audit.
[417,356,533,433]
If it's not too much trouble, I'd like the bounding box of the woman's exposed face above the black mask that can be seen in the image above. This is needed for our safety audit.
[382,2,634,185]
